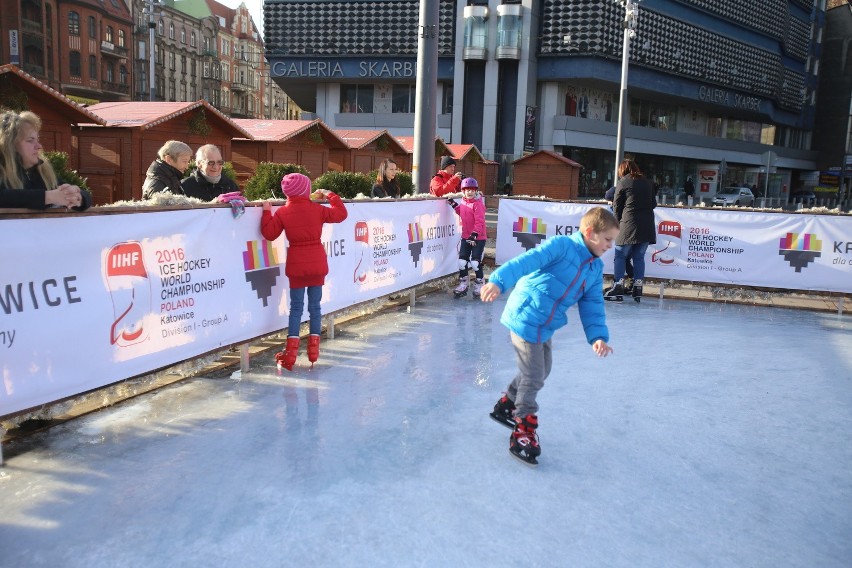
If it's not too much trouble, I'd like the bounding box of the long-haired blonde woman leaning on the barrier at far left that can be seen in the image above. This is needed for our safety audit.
[0,111,92,211]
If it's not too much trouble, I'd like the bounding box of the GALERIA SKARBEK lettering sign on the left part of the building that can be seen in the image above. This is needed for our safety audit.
[272,59,416,79]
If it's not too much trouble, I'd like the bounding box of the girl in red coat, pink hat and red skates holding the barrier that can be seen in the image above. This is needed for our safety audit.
[260,173,346,371]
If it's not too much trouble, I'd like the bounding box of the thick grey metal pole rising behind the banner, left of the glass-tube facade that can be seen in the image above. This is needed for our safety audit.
[411,0,440,193]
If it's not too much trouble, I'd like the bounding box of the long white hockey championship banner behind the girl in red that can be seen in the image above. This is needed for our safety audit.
[0,200,459,416]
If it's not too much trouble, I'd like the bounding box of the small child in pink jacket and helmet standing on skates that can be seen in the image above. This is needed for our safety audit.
[447,178,486,298]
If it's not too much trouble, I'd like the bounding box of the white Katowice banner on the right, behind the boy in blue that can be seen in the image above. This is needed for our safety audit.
[496,199,852,293]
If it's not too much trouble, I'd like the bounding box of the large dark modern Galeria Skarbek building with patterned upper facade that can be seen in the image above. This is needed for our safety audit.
[264,0,825,197]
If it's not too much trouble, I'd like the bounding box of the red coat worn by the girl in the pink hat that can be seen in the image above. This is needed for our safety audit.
[260,193,347,288]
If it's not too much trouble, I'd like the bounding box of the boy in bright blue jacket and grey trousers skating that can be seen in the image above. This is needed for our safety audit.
[480,207,618,465]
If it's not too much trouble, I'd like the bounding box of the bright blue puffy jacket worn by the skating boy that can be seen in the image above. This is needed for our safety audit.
[488,232,609,344]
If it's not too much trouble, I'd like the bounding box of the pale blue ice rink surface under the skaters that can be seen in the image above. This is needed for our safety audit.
[0,293,852,568]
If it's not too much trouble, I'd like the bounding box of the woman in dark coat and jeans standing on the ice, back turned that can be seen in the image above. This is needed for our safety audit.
[604,160,657,302]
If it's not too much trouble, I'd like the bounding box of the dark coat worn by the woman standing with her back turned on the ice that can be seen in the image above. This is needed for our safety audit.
[612,176,657,245]
